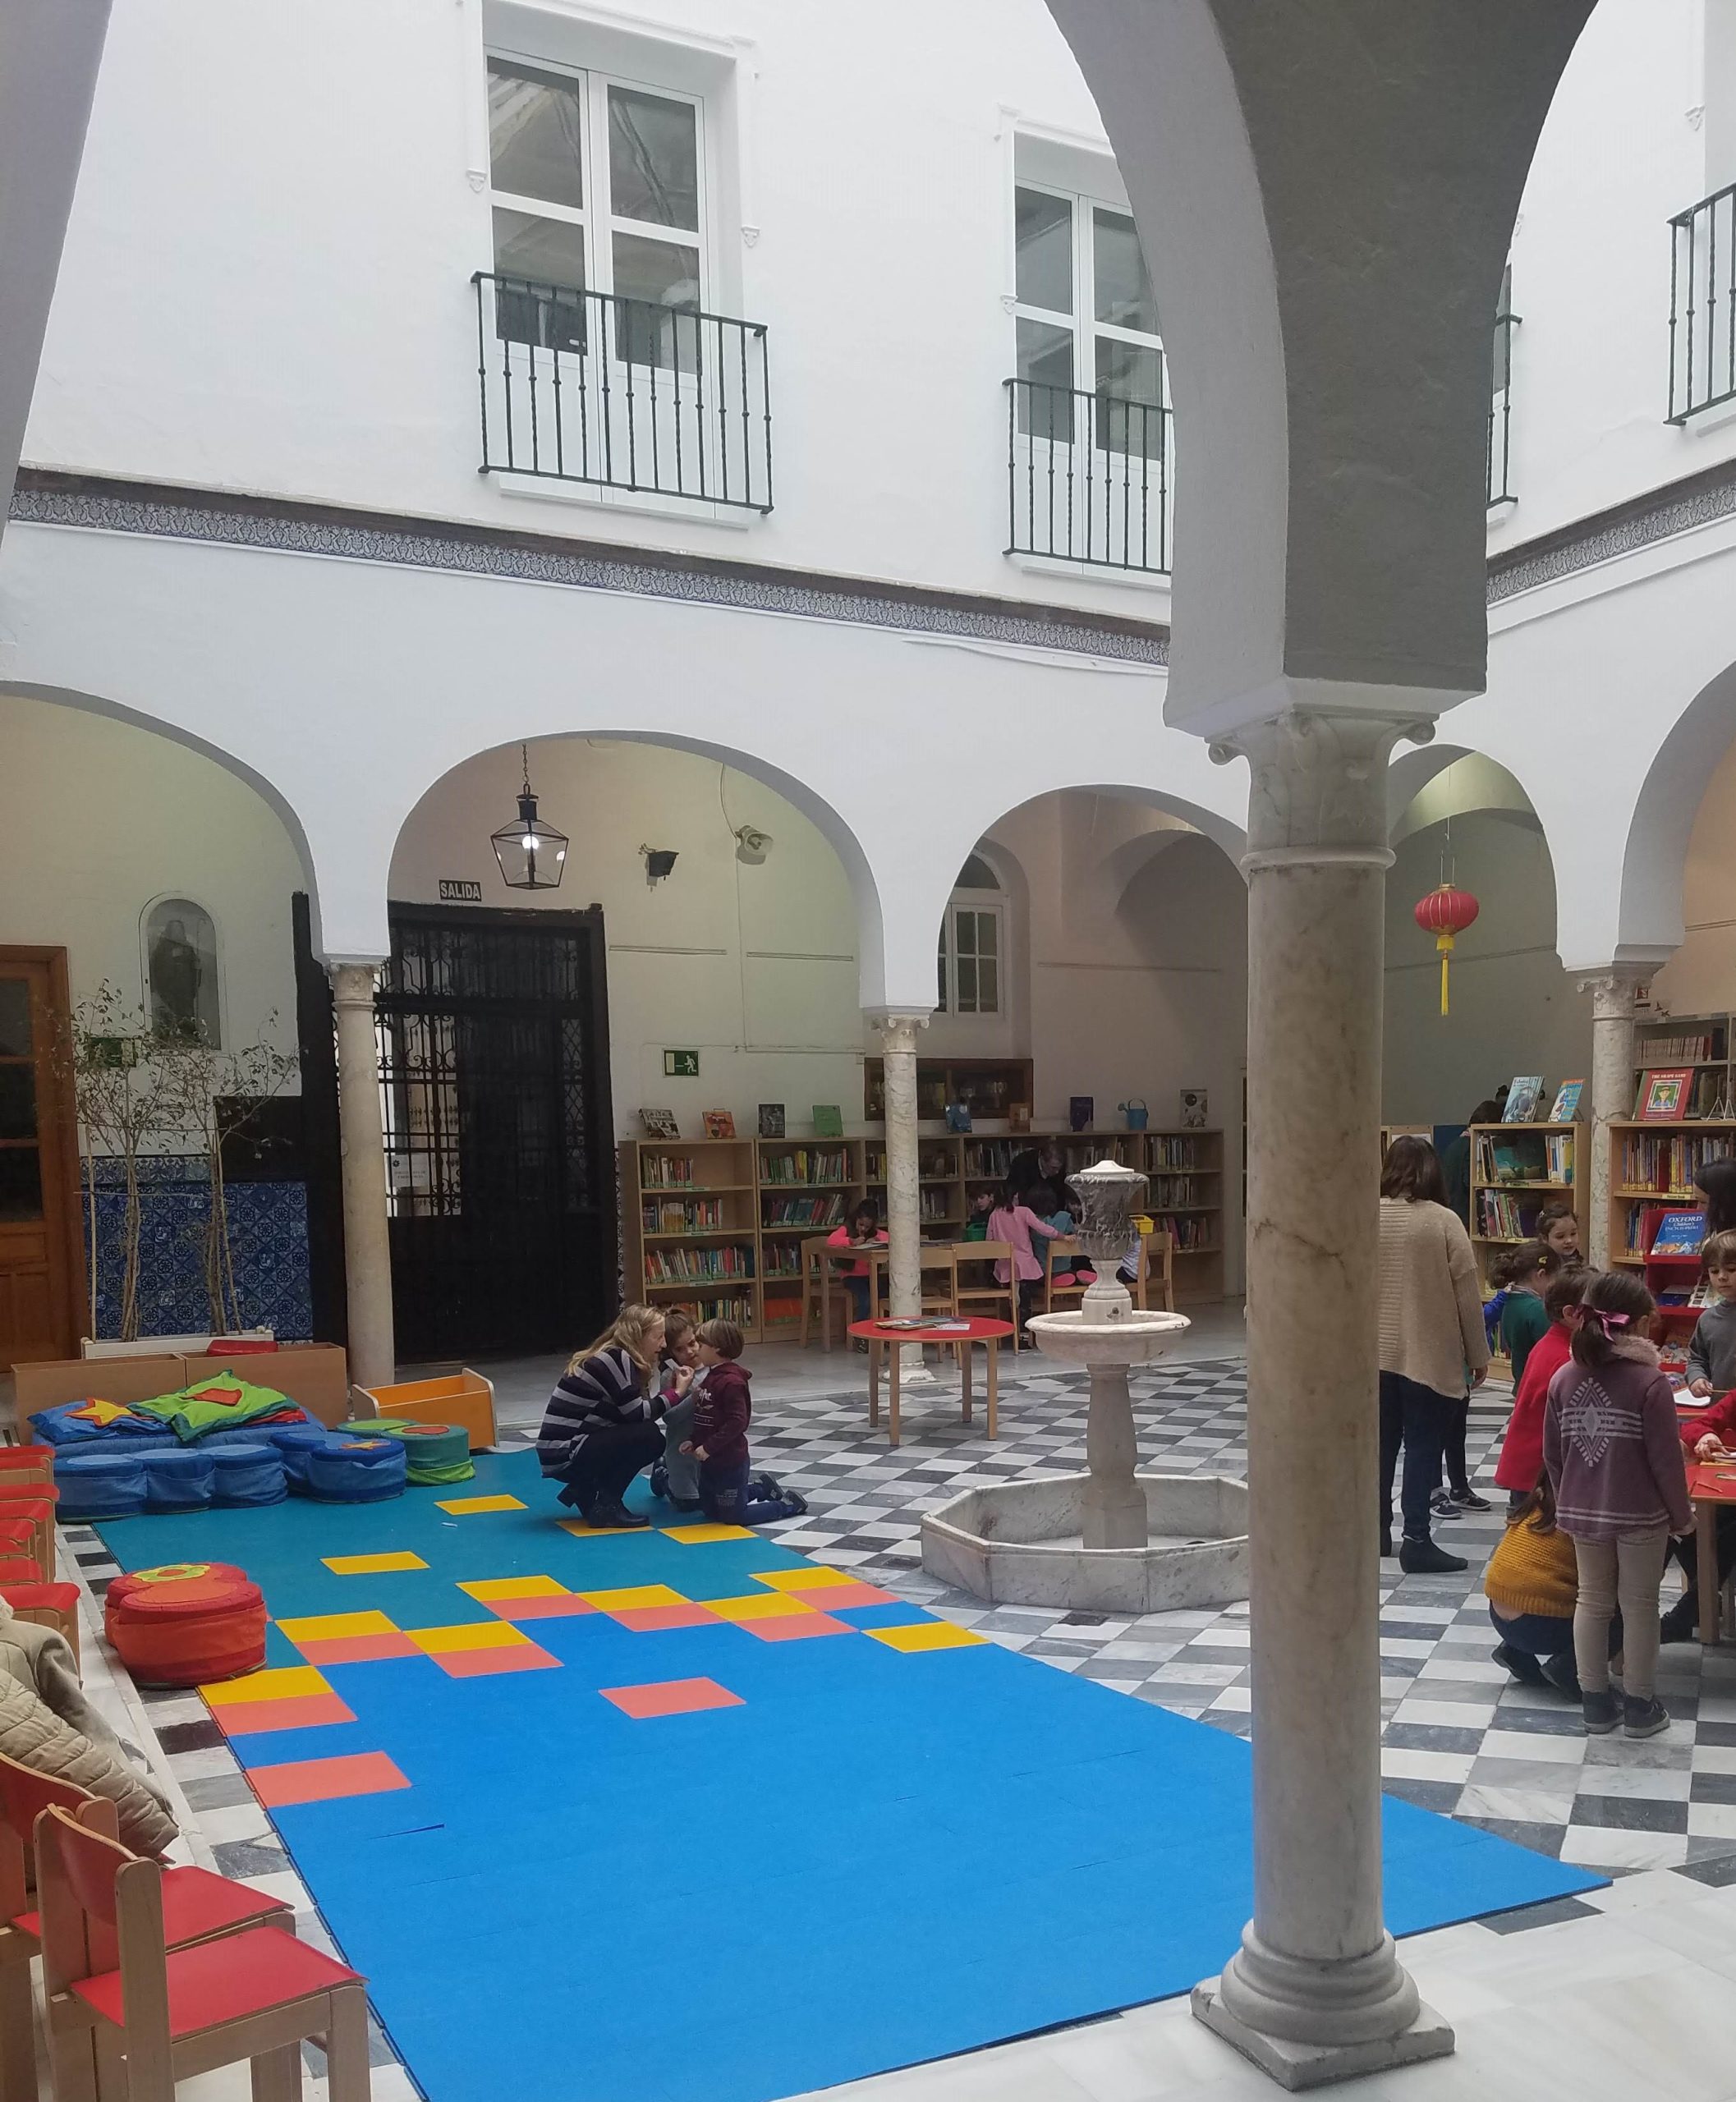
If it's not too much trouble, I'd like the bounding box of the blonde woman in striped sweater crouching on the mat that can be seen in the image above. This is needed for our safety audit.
[536,1306,664,1526]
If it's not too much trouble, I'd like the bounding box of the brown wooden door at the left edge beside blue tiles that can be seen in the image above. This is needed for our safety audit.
[0,948,84,1366]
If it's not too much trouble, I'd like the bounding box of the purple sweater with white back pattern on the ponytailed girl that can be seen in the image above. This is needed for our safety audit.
[1543,1337,1694,1540]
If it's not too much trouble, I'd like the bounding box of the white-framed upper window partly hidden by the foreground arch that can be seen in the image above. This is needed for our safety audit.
[1013,181,1169,458]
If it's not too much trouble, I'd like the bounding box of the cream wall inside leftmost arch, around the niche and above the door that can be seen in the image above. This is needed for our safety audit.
[0,691,305,1051]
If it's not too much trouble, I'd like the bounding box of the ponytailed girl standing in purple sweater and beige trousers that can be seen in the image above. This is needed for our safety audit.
[1543,1269,1694,1737]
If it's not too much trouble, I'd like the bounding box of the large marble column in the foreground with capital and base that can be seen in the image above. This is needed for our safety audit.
[1194,695,1452,2087]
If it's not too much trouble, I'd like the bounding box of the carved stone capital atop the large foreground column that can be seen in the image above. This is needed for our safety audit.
[1210,700,1435,870]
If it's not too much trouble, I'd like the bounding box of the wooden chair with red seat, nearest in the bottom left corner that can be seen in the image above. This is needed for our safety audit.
[36,1808,368,2102]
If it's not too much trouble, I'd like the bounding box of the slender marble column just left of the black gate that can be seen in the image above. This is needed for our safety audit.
[332,962,397,1388]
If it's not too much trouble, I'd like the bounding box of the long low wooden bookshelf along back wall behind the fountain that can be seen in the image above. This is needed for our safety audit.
[620,1131,1224,1343]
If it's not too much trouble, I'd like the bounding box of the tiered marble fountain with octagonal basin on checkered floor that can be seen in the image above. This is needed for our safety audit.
[923,1160,1248,1613]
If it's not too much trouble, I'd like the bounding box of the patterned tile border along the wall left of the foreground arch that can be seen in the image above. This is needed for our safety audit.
[11,469,1169,664]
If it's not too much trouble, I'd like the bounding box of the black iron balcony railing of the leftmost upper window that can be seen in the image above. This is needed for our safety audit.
[471,271,771,511]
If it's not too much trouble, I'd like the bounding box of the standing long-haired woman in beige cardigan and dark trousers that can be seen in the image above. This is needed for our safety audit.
[1379,1137,1488,1574]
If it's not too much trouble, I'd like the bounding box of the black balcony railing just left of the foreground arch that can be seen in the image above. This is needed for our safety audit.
[1007,364,1175,574]
